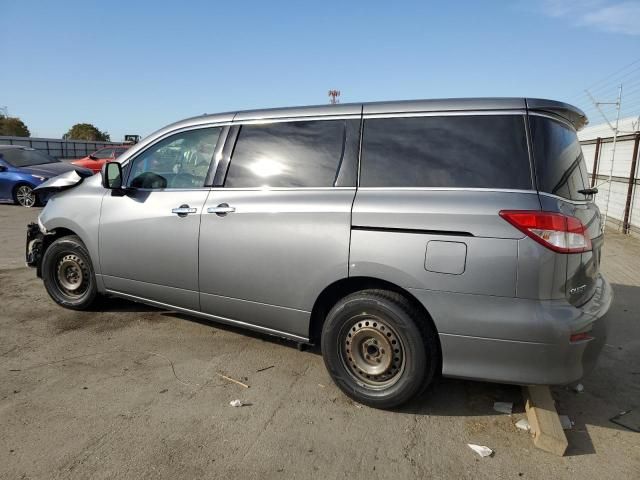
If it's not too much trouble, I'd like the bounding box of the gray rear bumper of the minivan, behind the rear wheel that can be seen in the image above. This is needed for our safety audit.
[411,277,613,385]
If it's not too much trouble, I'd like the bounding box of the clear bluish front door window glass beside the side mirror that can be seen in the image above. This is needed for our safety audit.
[129,127,221,189]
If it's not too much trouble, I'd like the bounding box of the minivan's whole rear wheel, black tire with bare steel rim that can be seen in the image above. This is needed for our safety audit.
[321,290,440,408]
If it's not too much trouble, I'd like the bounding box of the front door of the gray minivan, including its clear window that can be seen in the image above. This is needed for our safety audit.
[100,127,221,310]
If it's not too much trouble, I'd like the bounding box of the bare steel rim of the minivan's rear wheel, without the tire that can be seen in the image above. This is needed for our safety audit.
[339,314,406,390]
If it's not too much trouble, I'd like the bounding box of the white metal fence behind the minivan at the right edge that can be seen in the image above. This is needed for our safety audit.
[580,132,640,235]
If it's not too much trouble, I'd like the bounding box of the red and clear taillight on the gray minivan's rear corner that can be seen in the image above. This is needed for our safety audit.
[500,210,591,253]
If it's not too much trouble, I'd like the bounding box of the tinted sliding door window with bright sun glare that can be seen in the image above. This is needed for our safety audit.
[225,120,345,188]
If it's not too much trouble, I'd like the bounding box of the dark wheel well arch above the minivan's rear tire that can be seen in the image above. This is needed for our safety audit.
[309,277,441,354]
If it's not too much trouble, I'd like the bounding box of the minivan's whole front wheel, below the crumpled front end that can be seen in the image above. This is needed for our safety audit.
[42,235,97,310]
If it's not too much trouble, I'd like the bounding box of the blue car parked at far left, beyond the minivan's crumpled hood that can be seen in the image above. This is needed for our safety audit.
[0,145,93,207]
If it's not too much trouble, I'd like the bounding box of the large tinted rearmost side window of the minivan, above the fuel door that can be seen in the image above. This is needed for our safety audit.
[360,115,531,189]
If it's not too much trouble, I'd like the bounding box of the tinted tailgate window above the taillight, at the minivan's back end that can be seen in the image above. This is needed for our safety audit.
[530,115,589,200]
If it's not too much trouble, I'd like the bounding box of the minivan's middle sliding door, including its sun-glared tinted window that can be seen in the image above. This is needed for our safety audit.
[200,119,359,338]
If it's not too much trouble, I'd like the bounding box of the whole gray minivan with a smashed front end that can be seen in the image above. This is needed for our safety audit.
[27,98,612,408]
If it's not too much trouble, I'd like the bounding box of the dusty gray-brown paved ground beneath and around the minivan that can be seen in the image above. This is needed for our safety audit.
[0,205,640,479]
